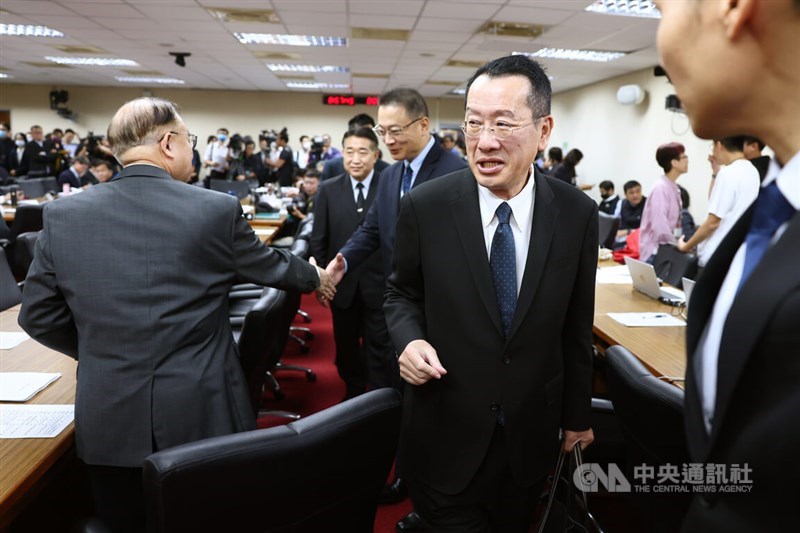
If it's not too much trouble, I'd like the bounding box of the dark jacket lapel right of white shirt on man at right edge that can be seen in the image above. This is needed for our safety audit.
[709,213,800,447]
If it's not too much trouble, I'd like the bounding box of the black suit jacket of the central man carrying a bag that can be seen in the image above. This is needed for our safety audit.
[384,169,598,494]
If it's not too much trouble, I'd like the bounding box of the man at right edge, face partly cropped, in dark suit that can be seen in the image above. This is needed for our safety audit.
[656,0,800,532]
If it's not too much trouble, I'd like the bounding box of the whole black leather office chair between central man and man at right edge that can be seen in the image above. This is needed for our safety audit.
[606,346,691,532]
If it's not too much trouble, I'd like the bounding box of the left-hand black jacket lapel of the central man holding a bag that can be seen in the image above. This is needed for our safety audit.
[450,169,503,335]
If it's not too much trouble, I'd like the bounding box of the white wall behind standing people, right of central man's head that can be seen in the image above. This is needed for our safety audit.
[550,69,711,220]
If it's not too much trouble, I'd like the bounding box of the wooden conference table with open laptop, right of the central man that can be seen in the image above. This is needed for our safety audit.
[593,263,686,387]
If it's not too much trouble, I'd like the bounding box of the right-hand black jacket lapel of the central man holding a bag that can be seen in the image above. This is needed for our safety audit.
[509,170,559,339]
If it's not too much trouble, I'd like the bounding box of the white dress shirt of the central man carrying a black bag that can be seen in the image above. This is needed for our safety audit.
[478,166,536,294]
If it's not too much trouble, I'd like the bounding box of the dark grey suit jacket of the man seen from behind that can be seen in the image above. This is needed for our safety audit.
[19,165,319,467]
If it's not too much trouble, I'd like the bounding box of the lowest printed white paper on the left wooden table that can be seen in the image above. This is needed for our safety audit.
[0,404,75,439]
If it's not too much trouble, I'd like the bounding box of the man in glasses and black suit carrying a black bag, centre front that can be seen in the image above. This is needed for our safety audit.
[384,56,597,532]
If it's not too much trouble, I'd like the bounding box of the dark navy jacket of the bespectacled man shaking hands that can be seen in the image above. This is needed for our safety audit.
[341,137,467,278]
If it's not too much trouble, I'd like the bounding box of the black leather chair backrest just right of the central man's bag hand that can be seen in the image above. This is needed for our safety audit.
[606,346,689,465]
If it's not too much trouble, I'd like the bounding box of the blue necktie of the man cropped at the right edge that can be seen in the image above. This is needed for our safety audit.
[737,181,796,291]
